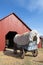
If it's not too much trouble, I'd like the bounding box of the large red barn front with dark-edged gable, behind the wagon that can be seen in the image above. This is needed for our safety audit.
[0,13,31,51]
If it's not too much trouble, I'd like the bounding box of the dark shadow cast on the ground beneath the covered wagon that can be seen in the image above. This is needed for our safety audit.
[3,50,33,58]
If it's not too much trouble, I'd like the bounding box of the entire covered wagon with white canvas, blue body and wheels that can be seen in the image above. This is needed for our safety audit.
[13,30,40,58]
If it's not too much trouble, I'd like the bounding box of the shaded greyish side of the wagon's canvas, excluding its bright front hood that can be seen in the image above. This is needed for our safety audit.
[14,32,29,45]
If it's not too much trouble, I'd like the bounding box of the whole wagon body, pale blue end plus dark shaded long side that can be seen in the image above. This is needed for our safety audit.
[17,41,38,51]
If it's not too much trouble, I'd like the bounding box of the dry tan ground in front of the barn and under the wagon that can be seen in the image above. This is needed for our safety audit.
[0,49,43,65]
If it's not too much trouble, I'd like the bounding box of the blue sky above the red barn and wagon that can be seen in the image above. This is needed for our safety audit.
[0,0,43,35]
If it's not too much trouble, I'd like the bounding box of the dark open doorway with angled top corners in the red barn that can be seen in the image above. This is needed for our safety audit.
[5,31,17,48]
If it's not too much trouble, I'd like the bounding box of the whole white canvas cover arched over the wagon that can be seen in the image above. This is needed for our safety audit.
[14,30,40,45]
